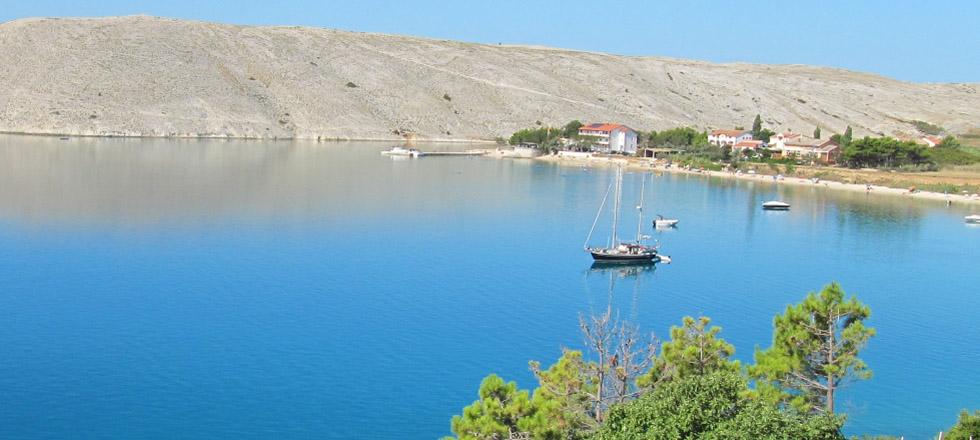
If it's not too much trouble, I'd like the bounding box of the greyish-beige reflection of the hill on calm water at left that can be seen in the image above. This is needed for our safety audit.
[0,136,506,227]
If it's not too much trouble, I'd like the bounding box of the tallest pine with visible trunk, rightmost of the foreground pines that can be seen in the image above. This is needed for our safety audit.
[749,283,875,414]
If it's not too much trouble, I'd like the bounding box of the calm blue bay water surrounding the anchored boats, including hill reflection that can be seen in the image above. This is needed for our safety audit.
[0,137,980,439]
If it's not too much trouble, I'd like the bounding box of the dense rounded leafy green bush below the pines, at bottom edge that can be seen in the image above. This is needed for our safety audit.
[593,371,843,440]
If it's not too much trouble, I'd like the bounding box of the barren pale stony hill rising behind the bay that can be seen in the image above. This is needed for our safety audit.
[0,16,980,139]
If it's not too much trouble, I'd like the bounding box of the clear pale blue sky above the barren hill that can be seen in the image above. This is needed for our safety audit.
[0,0,980,82]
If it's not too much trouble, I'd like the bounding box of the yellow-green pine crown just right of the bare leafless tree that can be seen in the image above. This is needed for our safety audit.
[637,316,740,388]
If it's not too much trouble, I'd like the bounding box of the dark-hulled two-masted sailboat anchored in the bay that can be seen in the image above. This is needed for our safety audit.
[584,167,659,264]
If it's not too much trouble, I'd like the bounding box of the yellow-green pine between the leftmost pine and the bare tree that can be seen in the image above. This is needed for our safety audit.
[529,350,598,439]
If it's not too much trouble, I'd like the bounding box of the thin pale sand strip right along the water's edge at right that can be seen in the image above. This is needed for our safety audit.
[535,155,980,206]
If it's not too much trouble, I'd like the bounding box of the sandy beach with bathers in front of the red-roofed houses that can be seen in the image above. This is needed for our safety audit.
[535,155,980,206]
